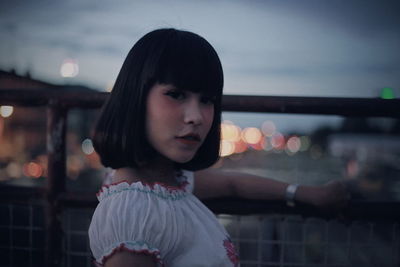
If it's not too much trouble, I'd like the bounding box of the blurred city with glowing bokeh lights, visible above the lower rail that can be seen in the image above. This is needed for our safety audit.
[0,69,400,200]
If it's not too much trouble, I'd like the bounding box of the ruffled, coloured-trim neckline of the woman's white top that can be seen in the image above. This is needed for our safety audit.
[96,171,189,201]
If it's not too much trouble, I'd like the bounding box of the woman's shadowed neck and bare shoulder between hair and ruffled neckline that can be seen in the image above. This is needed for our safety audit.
[113,157,178,186]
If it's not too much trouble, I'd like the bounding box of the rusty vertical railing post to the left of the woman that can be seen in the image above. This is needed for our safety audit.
[46,100,67,267]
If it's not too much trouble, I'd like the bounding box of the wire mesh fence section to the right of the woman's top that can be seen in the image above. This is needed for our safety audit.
[219,215,400,267]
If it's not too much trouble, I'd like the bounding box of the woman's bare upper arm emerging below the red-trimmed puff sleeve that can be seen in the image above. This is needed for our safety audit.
[104,251,157,267]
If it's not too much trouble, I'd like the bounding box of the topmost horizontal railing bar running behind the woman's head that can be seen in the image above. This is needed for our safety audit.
[0,89,400,118]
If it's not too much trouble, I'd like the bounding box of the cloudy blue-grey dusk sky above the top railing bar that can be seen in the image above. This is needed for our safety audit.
[0,0,400,132]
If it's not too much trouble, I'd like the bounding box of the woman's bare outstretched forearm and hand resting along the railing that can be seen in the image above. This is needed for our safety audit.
[194,169,349,208]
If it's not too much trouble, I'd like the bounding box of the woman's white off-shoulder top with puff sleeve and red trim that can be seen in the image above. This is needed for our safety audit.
[89,171,239,267]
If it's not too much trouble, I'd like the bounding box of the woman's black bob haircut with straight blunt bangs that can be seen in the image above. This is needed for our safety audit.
[93,29,223,171]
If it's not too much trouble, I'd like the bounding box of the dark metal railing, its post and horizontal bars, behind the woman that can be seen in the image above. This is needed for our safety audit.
[0,88,400,267]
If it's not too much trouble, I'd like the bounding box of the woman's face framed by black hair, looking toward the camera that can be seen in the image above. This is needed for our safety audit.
[146,83,214,163]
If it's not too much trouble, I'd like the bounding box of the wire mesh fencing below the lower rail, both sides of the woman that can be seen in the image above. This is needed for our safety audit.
[0,202,400,267]
